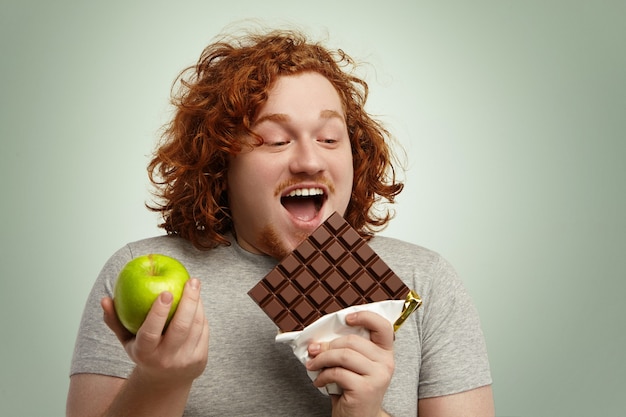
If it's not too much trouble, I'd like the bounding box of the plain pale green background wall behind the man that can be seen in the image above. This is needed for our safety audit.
[0,0,626,417]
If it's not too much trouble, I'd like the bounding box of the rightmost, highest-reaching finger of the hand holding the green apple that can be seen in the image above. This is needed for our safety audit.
[165,278,201,346]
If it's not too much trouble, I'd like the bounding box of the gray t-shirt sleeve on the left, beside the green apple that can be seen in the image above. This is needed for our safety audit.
[70,247,135,378]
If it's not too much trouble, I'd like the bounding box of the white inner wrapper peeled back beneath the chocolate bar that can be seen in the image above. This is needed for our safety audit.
[276,300,405,395]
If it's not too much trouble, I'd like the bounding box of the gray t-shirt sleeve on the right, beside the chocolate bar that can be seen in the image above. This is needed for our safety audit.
[418,257,492,398]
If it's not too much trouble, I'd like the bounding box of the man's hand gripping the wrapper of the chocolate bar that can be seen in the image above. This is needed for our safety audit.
[306,311,395,417]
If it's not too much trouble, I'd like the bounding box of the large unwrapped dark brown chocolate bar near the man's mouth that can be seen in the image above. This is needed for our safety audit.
[248,213,410,332]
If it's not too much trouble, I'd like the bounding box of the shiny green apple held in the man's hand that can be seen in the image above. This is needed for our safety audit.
[113,254,189,334]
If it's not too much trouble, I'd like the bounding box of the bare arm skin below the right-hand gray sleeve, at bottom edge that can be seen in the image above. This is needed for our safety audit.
[418,385,495,417]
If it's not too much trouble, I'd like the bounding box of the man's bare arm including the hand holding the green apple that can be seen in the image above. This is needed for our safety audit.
[67,279,208,417]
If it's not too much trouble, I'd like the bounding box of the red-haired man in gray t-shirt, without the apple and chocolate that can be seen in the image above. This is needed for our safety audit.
[67,27,494,417]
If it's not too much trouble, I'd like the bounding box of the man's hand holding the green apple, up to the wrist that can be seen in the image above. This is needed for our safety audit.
[101,278,209,386]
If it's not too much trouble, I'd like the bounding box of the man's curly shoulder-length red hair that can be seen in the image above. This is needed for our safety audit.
[147,30,403,249]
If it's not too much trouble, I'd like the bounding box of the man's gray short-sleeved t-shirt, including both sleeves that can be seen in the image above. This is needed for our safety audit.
[71,232,491,417]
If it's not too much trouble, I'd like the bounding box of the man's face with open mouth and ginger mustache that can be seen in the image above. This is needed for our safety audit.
[228,72,354,259]
